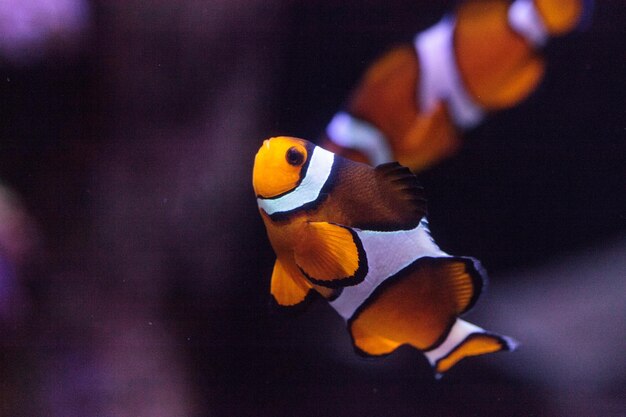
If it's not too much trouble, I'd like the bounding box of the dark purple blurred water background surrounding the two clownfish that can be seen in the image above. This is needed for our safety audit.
[0,0,626,417]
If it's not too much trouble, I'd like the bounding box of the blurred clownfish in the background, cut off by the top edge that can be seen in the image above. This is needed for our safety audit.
[321,0,591,171]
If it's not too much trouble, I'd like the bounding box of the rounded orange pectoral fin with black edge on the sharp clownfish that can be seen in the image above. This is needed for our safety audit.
[295,222,367,288]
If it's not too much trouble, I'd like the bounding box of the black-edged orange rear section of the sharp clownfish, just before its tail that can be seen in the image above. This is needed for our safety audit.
[348,257,482,354]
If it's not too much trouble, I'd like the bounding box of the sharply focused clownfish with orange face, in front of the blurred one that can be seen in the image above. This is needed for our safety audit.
[252,137,516,376]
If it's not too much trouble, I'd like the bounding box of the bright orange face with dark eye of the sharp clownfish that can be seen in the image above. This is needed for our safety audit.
[252,136,312,198]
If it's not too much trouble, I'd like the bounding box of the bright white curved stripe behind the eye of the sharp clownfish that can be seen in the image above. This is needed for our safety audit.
[257,146,335,216]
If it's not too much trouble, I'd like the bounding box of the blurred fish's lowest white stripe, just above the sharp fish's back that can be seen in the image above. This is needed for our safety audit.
[326,112,394,166]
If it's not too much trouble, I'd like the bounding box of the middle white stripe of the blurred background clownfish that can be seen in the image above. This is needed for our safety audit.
[415,18,484,128]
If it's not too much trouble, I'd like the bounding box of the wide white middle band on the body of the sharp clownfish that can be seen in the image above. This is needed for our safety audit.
[330,219,450,320]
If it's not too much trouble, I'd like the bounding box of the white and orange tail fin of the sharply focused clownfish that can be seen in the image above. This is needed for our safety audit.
[424,319,517,379]
